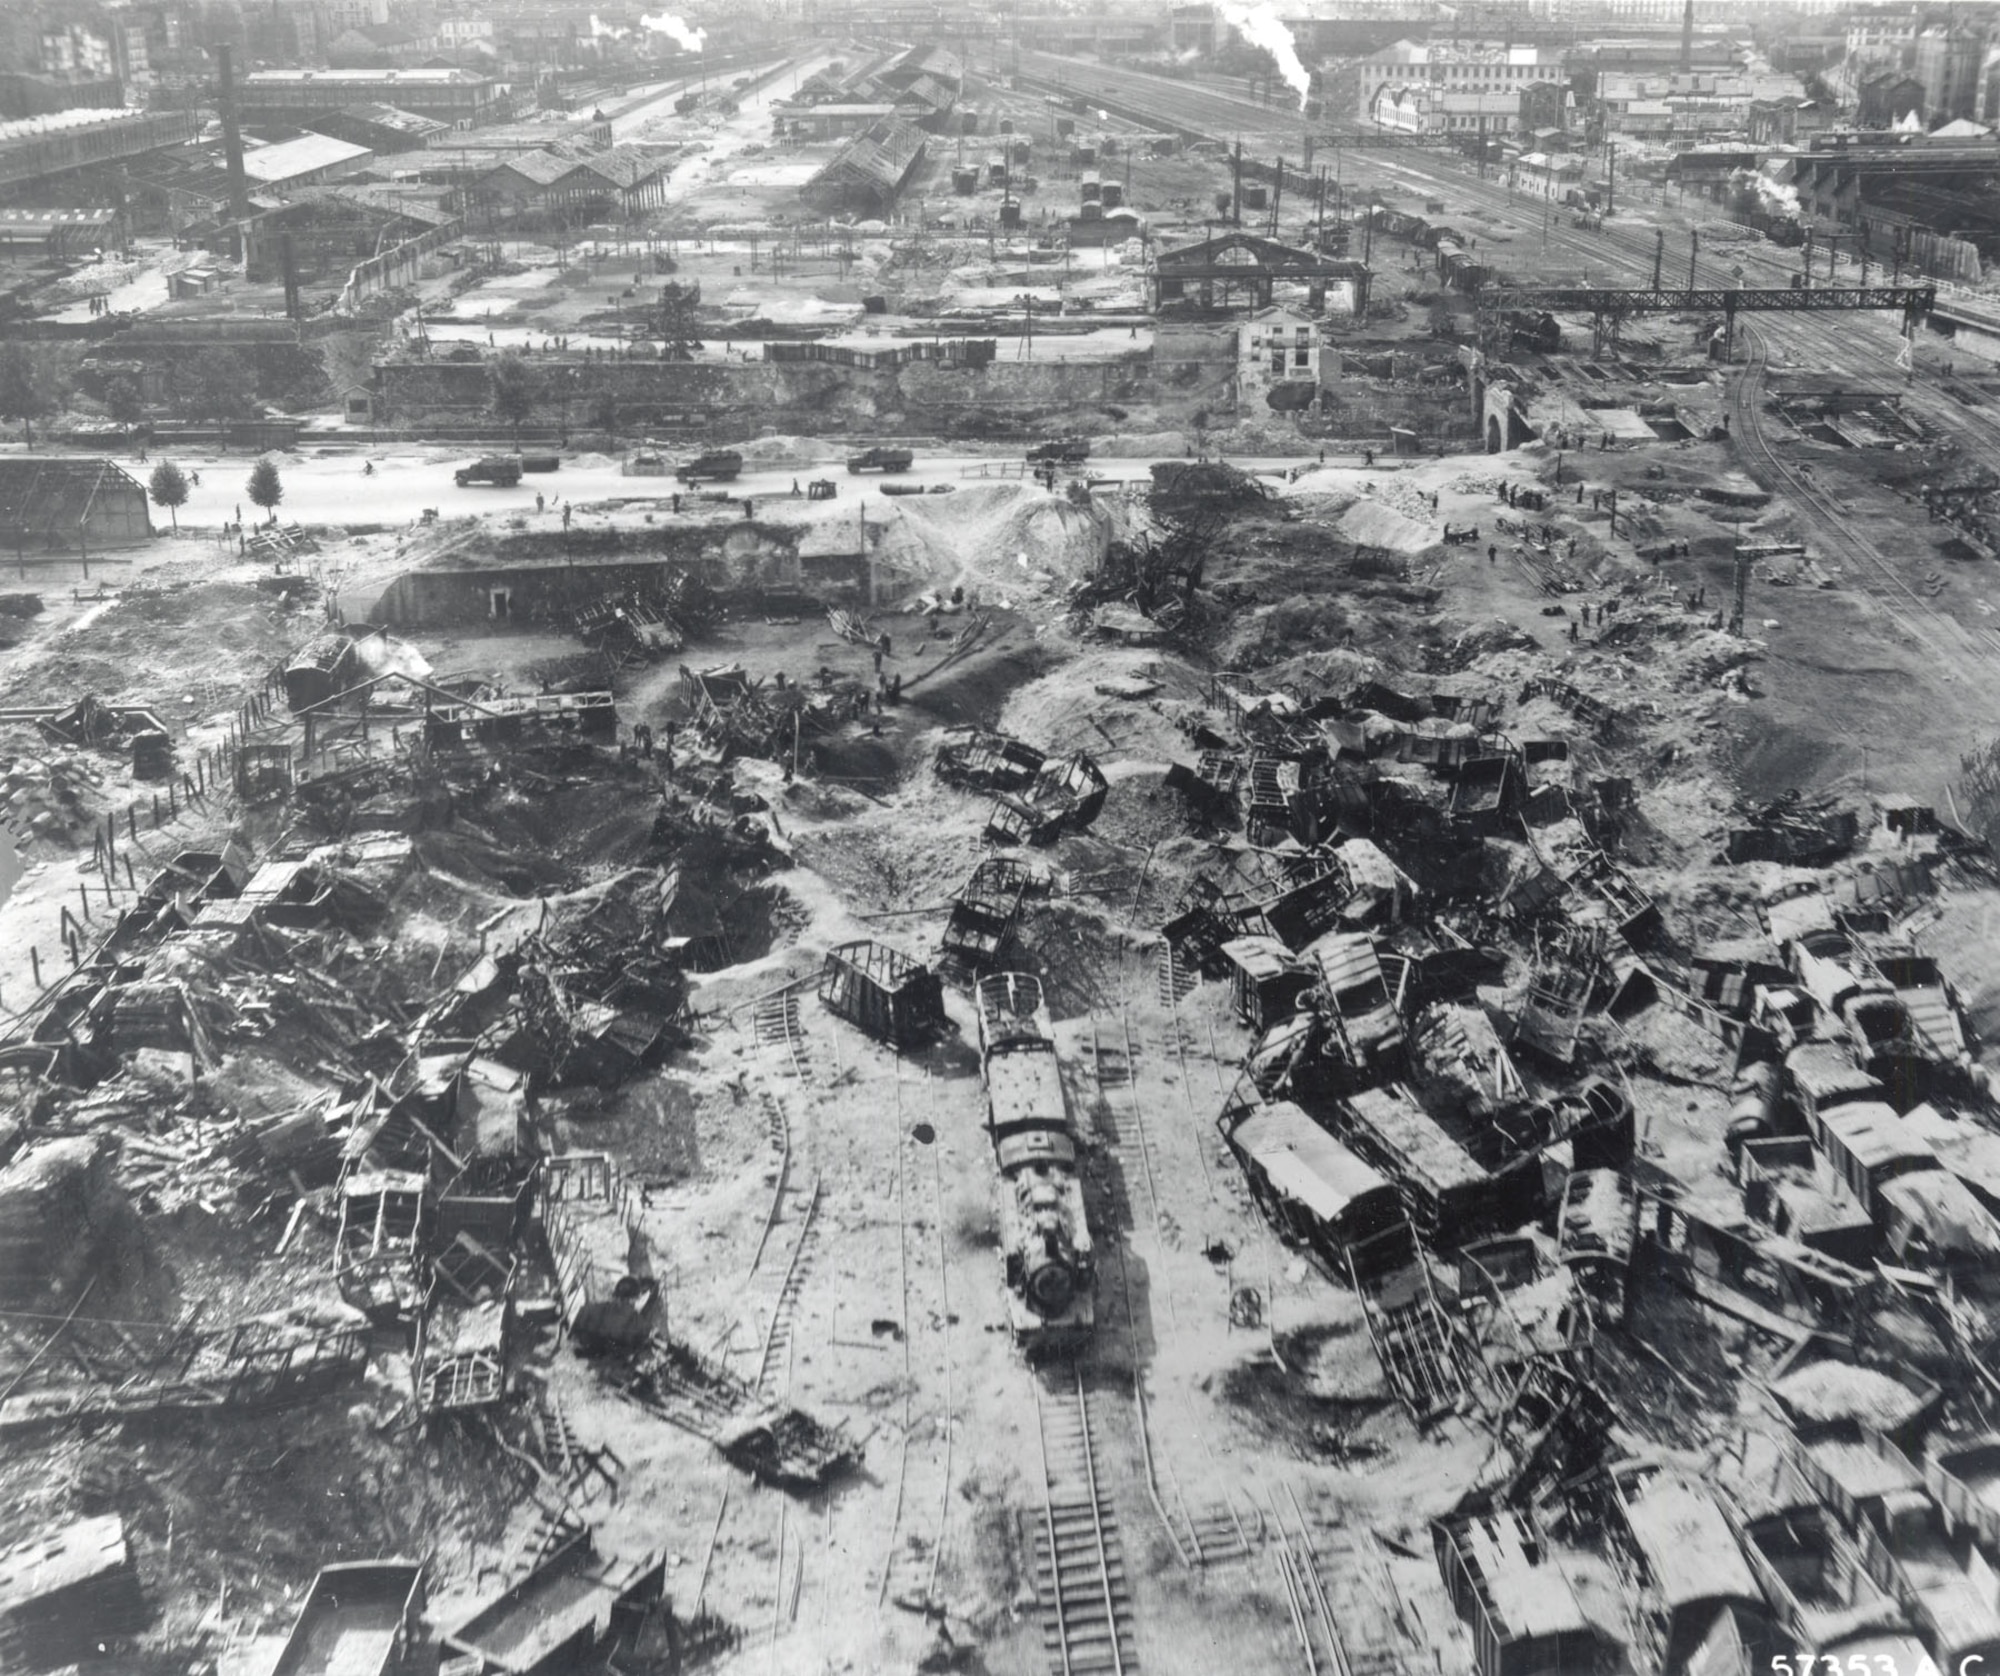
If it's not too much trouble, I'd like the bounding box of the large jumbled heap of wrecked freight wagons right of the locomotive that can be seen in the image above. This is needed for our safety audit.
[1152,624,2000,1668]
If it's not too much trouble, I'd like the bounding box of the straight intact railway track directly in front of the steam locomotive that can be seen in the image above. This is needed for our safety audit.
[1034,1366,1138,1676]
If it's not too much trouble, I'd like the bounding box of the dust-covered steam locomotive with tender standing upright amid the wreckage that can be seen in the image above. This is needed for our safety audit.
[974,972,1096,1352]
